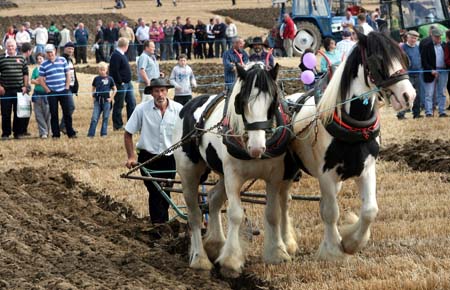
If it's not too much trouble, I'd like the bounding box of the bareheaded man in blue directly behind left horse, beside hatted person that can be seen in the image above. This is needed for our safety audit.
[222,37,248,92]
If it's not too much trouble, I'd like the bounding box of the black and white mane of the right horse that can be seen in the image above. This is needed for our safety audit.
[318,32,406,123]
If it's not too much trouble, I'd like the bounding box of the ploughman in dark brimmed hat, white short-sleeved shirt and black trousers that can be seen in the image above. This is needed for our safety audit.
[124,78,183,224]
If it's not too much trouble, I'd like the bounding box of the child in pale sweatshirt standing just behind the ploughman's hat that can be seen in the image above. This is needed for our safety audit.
[170,53,197,105]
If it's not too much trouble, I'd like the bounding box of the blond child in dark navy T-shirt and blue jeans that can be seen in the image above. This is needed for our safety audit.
[88,62,117,137]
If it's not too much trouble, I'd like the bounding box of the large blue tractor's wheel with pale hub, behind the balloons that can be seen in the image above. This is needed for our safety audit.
[293,21,322,56]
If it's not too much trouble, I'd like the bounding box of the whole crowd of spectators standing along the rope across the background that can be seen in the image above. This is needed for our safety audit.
[0,11,450,143]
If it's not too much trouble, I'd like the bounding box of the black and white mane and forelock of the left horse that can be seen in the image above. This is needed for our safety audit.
[227,62,278,135]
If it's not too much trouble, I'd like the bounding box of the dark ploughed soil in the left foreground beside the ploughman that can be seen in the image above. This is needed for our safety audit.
[0,168,271,289]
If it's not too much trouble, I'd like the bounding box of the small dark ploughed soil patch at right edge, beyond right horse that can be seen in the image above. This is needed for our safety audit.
[380,139,450,176]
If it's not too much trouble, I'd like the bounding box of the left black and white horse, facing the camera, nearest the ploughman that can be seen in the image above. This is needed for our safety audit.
[174,63,297,276]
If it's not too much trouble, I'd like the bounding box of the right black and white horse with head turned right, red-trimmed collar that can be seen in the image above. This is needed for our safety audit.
[281,32,416,260]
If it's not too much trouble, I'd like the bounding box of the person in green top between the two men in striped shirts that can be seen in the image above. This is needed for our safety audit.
[31,52,51,139]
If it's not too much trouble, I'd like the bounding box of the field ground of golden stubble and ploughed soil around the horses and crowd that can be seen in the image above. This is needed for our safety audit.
[0,0,450,289]
